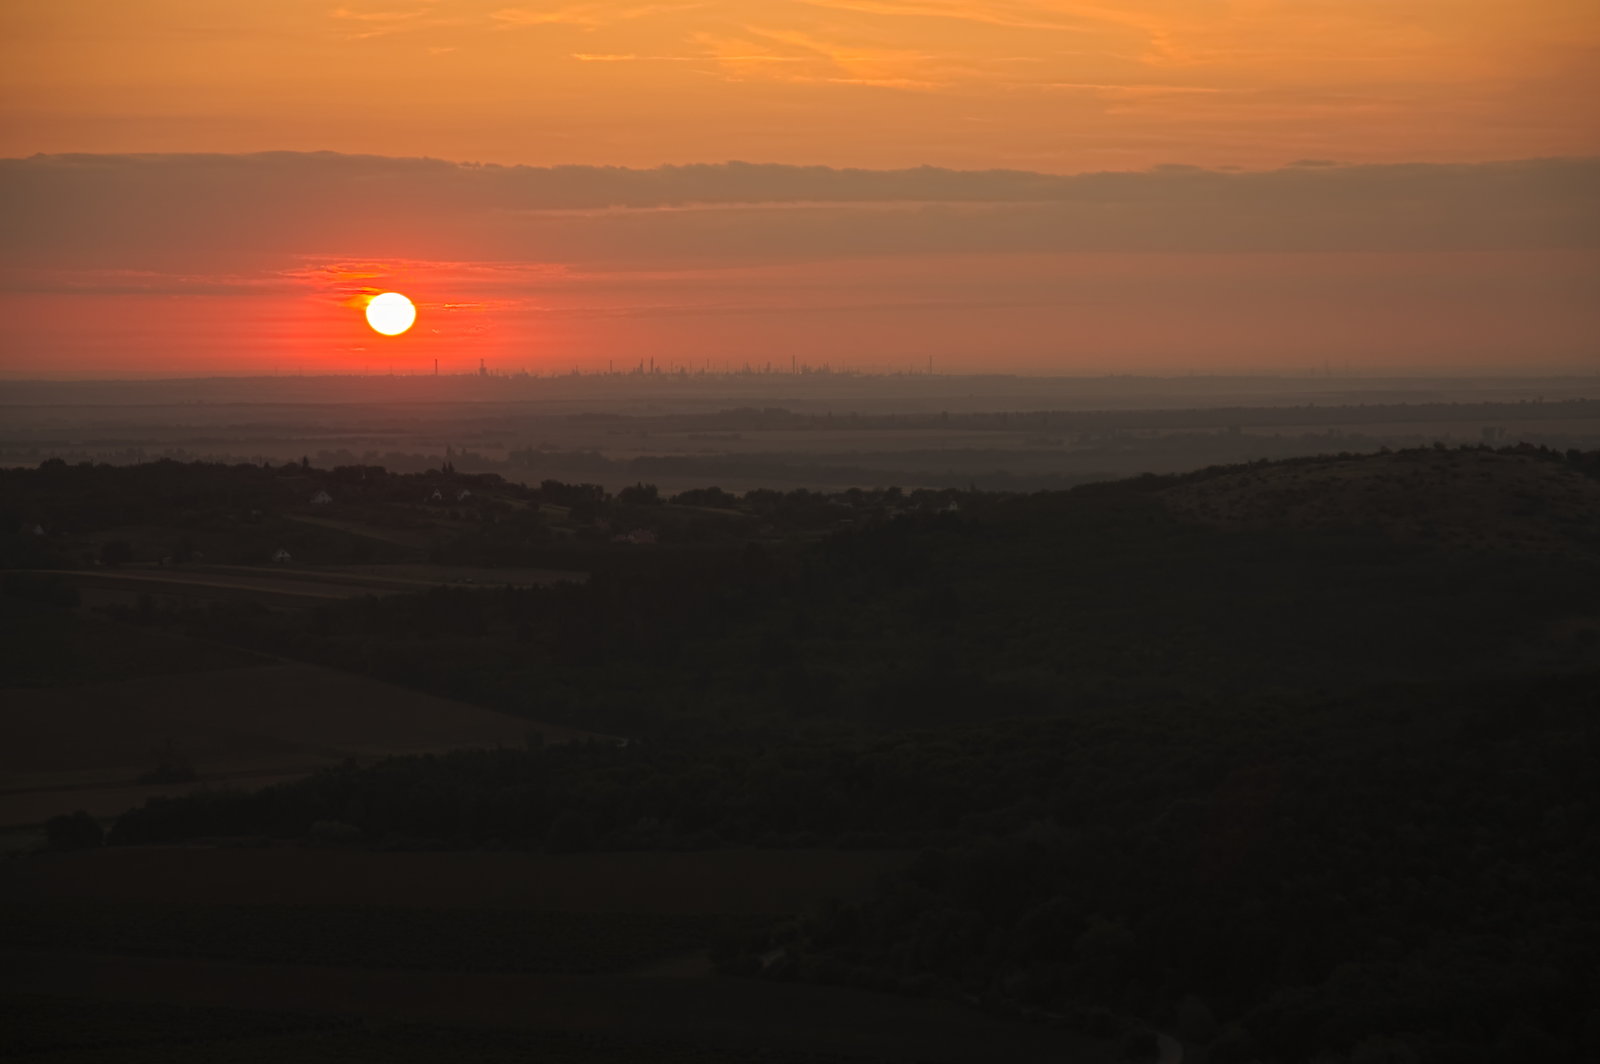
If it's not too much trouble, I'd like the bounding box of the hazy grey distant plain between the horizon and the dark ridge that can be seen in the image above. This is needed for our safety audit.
[0,373,1600,491]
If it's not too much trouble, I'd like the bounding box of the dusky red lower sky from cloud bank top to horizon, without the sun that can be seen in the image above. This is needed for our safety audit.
[0,154,1600,376]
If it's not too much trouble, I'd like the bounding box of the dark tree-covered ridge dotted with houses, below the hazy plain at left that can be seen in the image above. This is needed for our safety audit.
[0,459,992,568]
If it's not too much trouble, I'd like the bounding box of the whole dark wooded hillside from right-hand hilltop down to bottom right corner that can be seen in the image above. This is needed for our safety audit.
[3,451,1600,1061]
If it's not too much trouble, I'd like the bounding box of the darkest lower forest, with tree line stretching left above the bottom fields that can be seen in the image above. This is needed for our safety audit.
[110,675,1600,1061]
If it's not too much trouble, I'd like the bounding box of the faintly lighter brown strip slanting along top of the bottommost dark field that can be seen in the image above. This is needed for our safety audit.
[0,949,1112,1064]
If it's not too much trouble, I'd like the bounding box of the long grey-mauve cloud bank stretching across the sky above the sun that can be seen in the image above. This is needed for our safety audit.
[0,152,1600,274]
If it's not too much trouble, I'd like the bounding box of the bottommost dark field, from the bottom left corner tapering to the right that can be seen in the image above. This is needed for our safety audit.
[0,952,1117,1064]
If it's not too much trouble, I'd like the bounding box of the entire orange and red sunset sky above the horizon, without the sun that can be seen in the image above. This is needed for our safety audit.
[0,0,1600,374]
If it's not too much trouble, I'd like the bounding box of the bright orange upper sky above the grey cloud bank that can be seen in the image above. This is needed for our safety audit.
[0,0,1600,171]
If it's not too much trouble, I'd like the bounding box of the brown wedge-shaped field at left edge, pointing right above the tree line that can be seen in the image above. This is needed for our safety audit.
[0,665,584,826]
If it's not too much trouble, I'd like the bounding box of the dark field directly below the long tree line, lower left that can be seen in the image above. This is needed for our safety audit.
[0,846,907,974]
